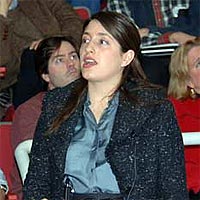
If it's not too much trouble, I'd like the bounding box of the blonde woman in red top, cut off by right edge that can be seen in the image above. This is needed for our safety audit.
[168,38,200,200]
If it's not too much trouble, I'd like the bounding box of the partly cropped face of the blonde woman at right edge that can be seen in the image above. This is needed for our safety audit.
[188,46,200,94]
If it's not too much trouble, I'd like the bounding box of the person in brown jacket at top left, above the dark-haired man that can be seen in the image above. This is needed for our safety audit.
[0,0,82,119]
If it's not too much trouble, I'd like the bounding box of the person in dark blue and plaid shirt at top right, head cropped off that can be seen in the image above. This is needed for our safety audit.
[107,0,200,87]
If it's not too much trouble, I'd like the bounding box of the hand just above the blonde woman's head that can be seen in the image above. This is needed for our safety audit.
[169,32,196,45]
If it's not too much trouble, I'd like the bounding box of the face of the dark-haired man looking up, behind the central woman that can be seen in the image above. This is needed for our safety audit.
[42,41,80,90]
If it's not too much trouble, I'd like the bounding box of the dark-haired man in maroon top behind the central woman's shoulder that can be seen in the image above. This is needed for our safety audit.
[11,36,80,200]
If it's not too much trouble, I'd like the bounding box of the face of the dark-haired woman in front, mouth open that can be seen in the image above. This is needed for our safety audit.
[80,20,133,84]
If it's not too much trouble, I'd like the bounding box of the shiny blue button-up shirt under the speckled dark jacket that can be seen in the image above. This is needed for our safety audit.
[65,94,120,193]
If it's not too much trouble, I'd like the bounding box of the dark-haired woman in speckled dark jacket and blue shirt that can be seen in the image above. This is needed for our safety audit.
[24,12,187,200]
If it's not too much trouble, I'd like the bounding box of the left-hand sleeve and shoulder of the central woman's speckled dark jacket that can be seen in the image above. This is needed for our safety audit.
[23,83,75,200]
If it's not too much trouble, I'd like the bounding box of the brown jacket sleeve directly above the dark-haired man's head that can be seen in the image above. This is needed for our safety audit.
[48,0,83,42]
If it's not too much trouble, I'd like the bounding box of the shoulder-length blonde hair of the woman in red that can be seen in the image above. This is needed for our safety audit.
[168,37,200,99]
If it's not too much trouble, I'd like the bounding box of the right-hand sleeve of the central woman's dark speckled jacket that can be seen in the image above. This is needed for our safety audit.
[157,101,188,200]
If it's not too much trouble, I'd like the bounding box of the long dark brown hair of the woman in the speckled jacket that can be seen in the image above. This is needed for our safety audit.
[49,11,150,132]
